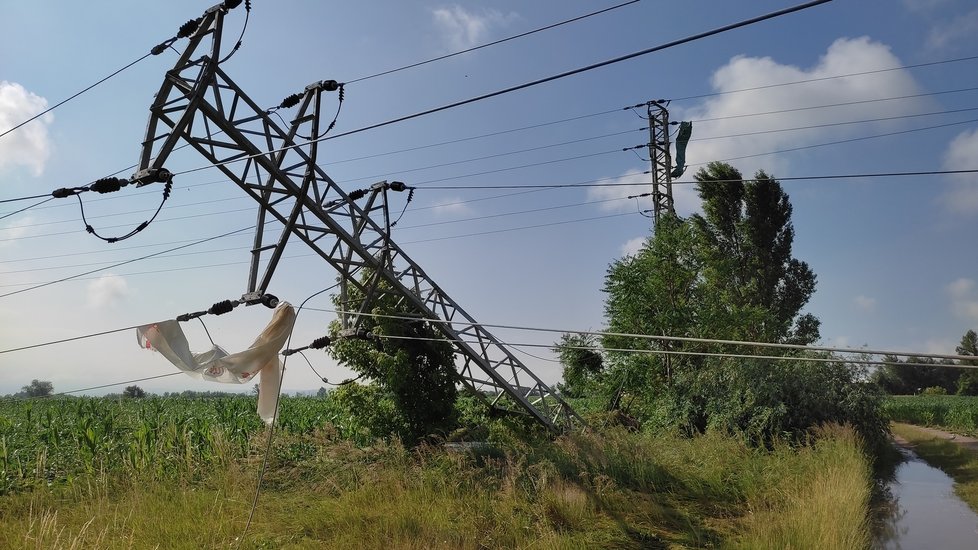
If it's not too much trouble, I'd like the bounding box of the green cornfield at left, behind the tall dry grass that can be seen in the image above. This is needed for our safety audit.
[0,395,362,495]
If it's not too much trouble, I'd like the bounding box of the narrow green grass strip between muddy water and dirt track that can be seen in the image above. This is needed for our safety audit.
[892,423,978,512]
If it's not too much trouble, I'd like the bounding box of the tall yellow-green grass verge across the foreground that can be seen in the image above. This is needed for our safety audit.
[0,428,871,549]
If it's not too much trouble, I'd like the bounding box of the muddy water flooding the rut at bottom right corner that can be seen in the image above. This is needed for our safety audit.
[877,450,978,550]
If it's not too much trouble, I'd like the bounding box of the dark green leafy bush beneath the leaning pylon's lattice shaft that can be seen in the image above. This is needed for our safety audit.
[327,272,458,445]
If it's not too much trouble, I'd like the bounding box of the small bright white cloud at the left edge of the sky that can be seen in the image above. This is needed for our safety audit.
[0,80,54,176]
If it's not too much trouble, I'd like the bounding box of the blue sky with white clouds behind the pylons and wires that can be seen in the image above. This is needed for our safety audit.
[0,0,978,394]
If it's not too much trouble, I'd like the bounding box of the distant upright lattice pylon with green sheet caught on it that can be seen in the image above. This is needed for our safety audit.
[645,99,693,225]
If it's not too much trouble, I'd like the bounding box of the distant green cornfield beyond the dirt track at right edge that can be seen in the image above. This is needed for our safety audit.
[883,395,978,434]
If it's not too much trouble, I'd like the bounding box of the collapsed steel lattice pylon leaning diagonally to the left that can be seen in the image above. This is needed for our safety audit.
[133,0,584,432]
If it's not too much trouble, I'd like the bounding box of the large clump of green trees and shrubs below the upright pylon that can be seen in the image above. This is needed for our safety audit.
[557,163,888,454]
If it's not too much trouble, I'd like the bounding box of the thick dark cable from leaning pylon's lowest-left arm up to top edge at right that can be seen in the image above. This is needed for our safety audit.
[168,0,832,179]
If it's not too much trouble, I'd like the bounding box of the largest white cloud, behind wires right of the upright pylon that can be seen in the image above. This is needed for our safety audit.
[673,37,927,176]
